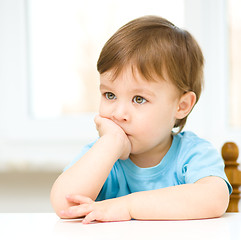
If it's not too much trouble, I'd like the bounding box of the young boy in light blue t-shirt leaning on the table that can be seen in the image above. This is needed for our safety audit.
[51,16,232,223]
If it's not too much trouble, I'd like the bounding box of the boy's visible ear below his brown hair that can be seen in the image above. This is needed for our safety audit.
[176,92,196,119]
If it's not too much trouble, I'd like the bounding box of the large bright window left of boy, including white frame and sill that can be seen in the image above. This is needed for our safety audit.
[0,0,185,171]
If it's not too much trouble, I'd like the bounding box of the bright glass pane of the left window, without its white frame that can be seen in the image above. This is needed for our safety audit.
[27,0,184,118]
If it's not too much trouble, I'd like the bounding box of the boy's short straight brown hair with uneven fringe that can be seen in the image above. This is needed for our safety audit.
[97,16,204,132]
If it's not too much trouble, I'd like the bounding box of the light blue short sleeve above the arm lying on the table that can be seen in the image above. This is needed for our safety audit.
[178,136,232,194]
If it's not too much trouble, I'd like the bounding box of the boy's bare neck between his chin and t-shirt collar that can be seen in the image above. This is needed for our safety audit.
[130,136,172,168]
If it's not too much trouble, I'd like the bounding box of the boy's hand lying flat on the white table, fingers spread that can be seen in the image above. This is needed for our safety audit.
[61,195,131,224]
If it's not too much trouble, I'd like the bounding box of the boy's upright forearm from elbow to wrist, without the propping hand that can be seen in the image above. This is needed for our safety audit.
[51,136,120,215]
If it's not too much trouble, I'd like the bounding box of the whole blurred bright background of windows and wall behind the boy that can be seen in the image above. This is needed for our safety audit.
[0,0,241,212]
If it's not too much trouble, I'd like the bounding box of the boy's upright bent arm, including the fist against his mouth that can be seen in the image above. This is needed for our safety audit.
[50,116,131,217]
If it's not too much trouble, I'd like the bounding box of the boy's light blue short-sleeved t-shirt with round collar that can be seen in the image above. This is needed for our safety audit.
[66,132,232,201]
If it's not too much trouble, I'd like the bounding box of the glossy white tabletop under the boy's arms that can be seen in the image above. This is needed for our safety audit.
[0,213,241,240]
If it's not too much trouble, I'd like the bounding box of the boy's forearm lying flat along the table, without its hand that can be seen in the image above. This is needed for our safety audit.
[128,178,229,219]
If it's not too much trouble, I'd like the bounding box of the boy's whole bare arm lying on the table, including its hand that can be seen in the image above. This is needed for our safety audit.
[60,174,229,223]
